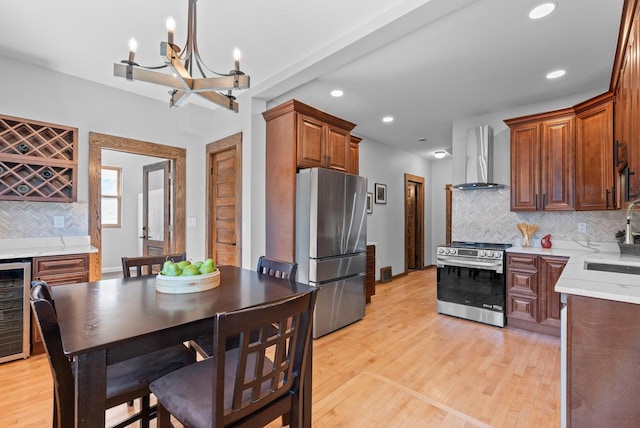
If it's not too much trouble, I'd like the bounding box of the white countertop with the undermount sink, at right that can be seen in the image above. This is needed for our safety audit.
[507,241,640,304]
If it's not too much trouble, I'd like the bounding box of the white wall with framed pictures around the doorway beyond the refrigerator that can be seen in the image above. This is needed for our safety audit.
[360,139,432,279]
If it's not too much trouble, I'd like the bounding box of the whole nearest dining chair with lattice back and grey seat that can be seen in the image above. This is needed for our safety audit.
[149,290,316,428]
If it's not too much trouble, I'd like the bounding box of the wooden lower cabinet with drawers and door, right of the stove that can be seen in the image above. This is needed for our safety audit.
[507,253,568,337]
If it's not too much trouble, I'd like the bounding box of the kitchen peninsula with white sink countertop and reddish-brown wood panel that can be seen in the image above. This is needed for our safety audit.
[510,242,640,427]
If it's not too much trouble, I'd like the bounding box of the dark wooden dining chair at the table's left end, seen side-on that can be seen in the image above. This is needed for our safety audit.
[31,281,195,428]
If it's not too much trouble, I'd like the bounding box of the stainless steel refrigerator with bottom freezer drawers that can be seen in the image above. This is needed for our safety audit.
[296,168,367,338]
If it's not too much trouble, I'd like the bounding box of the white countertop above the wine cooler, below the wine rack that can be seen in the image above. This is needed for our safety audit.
[0,236,98,260]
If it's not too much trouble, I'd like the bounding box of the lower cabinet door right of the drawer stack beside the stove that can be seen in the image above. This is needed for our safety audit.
[539,256,567,328]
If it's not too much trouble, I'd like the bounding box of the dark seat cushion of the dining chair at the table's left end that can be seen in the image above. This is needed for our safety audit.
[107,344,195,400]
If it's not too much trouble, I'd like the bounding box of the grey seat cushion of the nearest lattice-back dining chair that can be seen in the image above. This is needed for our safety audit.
[149,349,273,428]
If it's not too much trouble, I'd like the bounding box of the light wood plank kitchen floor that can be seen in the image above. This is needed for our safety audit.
[0,268,560,428]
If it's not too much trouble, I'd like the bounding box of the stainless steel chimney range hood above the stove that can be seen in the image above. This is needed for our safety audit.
[453,125,506,190]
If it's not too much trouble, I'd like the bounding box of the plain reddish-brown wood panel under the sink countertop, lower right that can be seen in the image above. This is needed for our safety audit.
[563,295,640,428]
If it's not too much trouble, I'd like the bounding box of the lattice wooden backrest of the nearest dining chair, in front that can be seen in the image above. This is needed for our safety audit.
[212,290,317,426]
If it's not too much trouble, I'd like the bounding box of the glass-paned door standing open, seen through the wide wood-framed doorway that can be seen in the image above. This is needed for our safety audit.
[140,160,171,256]
